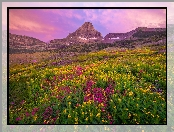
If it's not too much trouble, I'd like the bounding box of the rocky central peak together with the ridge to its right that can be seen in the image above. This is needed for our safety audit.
[49,22,166,48]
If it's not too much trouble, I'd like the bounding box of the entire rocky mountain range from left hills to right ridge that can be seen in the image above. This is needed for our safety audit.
[9,22,166,53]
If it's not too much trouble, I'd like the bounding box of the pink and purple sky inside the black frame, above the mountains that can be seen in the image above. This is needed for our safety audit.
[9,9,166,42]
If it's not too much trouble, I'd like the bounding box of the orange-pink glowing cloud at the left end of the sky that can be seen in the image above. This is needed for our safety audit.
[9,9,55,33]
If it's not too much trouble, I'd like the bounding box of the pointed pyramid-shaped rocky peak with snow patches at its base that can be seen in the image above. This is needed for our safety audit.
[50,22,103,45]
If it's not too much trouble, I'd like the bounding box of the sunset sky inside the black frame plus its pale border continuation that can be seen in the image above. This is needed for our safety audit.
[2,2,170,42]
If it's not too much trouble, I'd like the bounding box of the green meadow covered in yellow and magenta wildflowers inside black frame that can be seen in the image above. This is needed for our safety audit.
[9,47,166,124]
